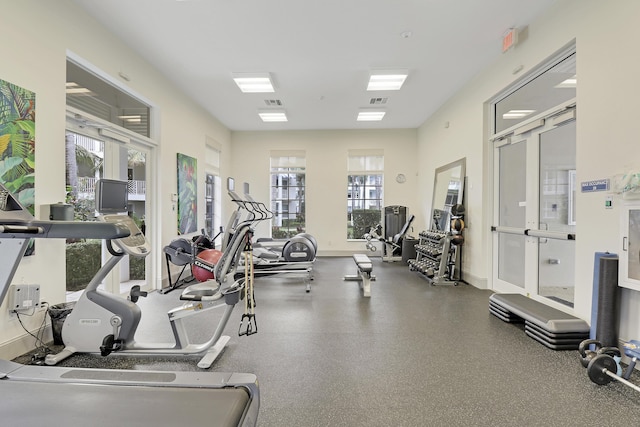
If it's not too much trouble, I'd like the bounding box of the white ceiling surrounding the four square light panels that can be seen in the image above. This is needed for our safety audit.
[73,0,557,131]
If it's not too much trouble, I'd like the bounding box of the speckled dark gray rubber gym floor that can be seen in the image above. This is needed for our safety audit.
[12,257,640,427]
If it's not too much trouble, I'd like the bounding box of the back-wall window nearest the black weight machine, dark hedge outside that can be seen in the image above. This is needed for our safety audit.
[347,150,384,239]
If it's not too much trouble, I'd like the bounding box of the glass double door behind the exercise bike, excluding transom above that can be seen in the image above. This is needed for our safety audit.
[66,124,152,301]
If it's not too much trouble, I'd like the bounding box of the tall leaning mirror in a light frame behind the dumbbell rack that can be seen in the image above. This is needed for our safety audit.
[431,157,465,231]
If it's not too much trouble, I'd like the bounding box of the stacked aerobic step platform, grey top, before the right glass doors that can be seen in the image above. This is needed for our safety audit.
[489,294,589,350]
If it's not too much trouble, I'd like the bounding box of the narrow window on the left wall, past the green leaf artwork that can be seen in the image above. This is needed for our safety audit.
[204,142,222,247]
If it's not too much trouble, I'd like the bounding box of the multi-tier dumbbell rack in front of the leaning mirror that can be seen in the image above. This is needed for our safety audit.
[409,230,460,286]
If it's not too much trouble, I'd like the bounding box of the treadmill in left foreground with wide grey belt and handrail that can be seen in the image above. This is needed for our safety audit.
[0,184,260,427]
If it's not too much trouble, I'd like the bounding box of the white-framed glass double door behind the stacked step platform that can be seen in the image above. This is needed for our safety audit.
[492,111,576,307]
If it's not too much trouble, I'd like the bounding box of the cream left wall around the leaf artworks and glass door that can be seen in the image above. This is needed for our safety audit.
[0,0,231,358]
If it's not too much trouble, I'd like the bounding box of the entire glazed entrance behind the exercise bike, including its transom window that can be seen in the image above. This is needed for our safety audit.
[65,55,159,301]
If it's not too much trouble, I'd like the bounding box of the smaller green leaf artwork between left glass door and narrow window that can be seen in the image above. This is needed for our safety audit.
[178,153,198,234]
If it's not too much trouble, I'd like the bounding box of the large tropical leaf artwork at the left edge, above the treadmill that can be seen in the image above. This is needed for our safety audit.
[0,79,36,255]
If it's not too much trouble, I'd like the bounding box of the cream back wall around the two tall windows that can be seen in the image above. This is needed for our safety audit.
[231,129,424,255]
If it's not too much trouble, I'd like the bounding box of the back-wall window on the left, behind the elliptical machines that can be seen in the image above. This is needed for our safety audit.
[271,151,306,239]
